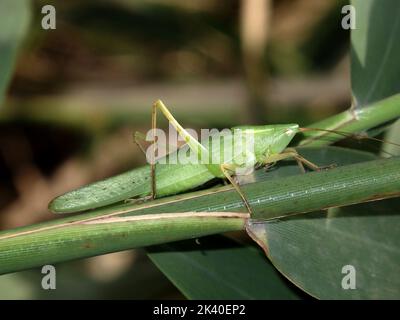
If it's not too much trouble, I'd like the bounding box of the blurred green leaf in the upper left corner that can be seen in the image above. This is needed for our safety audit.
[0,0,30,105]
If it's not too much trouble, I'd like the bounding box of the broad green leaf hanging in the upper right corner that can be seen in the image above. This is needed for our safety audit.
[351,0,400,108]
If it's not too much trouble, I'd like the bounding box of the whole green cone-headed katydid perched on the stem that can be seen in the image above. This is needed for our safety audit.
[49,100,398,213]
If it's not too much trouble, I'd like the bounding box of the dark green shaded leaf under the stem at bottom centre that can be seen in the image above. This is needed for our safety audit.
[149,236,300,299]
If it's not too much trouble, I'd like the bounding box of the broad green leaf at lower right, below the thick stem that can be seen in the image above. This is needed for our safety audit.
[249,150,400,299]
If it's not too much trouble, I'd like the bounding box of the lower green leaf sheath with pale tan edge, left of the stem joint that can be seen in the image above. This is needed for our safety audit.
[0,209,245,274]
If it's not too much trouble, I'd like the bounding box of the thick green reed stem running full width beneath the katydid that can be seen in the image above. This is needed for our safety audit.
[0,148,400,273]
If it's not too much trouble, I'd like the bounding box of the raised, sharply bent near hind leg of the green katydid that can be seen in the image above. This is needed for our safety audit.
[150,100,208,199]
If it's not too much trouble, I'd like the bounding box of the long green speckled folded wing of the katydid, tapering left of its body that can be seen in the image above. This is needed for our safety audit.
[49,164,214,213]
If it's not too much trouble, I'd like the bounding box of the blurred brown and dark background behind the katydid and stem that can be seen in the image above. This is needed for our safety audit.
[0,0,351,299]
